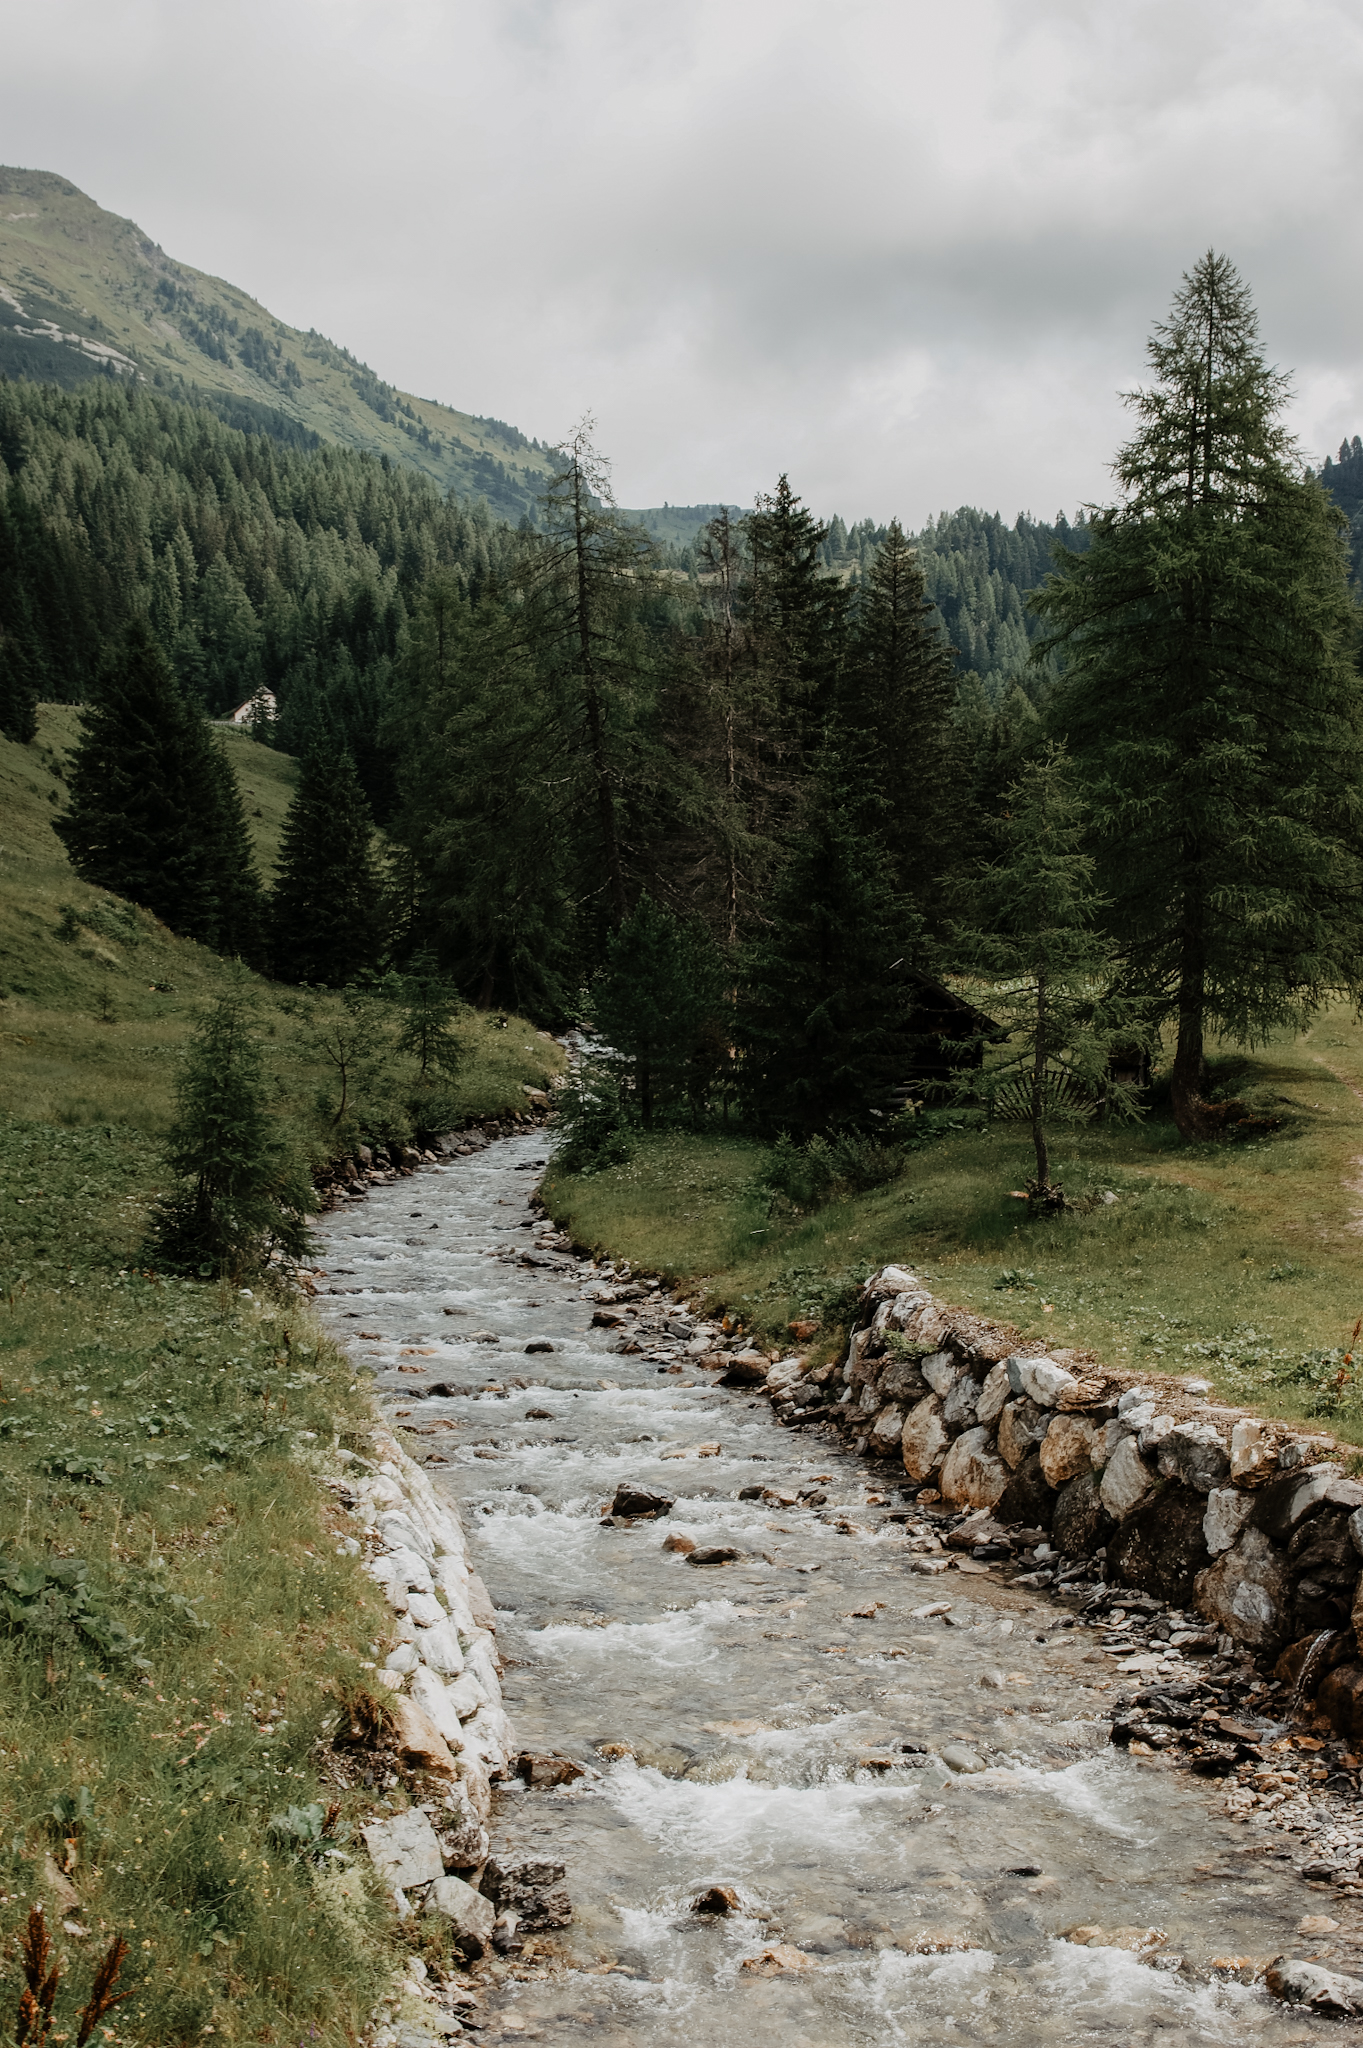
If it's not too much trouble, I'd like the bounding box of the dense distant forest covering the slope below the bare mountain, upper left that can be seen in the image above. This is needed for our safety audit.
[0,379,512,790]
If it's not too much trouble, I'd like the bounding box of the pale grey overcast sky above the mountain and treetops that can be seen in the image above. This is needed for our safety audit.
[0,0,1363,526]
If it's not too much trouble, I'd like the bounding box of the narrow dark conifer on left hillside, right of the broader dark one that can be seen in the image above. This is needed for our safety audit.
[270,752,383,989]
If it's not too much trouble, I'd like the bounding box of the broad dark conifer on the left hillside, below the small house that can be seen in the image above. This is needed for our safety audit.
[53,618,260,954]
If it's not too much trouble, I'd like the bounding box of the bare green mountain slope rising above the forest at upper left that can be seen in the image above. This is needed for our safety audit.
[0,168,553,520]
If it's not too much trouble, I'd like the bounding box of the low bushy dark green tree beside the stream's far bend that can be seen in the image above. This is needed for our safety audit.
[589,895,724,1130]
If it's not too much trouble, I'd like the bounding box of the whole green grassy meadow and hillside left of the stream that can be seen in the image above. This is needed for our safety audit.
[0,707,561,2048]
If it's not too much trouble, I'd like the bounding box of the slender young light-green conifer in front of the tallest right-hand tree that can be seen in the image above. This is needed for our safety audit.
[956,741,1138,1210]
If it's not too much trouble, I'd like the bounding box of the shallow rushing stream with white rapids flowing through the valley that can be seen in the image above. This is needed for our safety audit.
[321,1137,1351,2048]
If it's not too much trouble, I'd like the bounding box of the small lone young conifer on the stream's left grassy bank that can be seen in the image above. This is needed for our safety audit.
[147,979,313,1280]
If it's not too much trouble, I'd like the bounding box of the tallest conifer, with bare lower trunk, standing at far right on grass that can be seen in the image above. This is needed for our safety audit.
[1038,254,1363,1139]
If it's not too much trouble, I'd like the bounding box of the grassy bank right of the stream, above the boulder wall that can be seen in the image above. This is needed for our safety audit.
[546,1008,1363,1444]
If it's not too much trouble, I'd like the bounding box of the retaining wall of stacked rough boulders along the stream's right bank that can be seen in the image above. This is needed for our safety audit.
[765,1266,1363,1735]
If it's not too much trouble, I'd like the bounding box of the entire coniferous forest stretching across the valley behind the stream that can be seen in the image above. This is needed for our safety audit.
[10,254,1363,1200]
